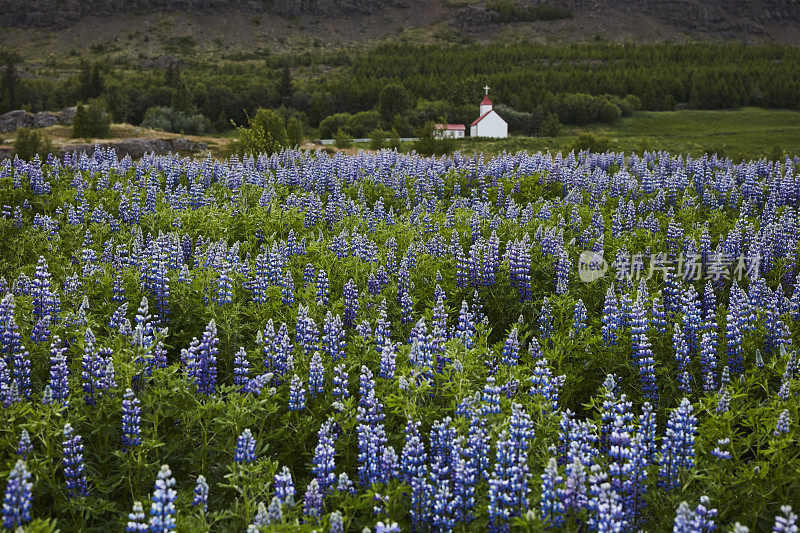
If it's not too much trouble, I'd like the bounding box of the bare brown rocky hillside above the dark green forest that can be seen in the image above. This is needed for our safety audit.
[0,0,800,44]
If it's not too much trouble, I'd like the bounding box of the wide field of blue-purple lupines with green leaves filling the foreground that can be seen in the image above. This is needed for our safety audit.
[0,143,800,532]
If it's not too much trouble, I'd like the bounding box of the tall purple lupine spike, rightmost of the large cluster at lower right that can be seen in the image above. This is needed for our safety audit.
[659,398,697,490]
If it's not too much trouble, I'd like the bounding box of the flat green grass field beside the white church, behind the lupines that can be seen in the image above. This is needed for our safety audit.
[459,107,800,159]
